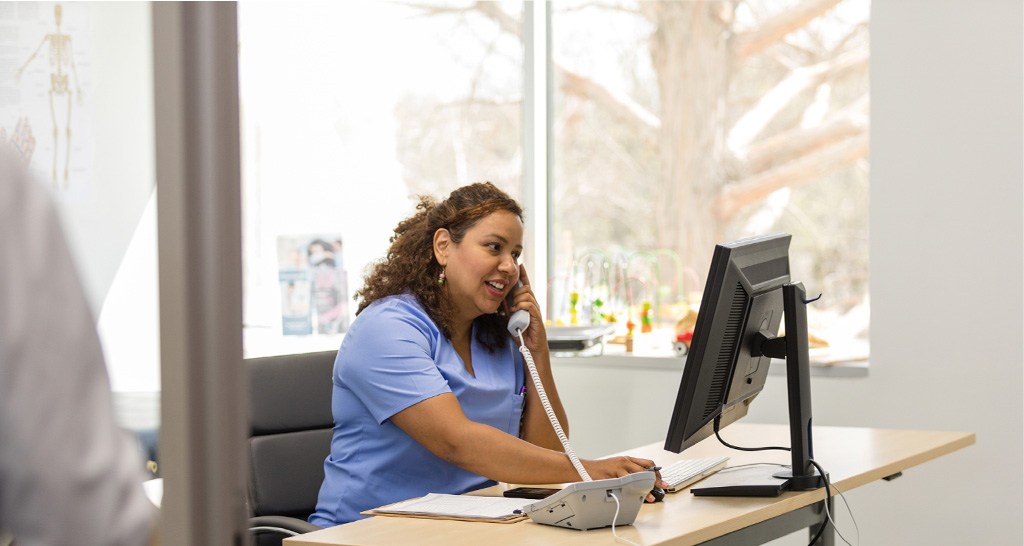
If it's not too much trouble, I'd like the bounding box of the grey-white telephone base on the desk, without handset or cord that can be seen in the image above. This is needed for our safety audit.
[522,472,654,531]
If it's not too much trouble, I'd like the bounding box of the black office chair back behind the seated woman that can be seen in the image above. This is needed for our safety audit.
[246,351,337,546]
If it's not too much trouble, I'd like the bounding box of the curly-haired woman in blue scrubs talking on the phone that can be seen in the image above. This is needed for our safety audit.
[309,182,667,527]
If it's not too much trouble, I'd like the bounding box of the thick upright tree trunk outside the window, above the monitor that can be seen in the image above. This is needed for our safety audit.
[642,2,732,295]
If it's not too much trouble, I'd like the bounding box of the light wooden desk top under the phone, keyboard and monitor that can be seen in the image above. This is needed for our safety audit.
[285,423,975,546]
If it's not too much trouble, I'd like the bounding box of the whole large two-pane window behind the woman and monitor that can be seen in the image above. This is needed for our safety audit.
[239,0,869,362]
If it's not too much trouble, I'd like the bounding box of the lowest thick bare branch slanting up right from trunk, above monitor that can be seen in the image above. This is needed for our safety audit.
[714,134,868,221]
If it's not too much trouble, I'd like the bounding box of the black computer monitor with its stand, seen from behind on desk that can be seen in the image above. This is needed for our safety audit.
[665,234,823,496]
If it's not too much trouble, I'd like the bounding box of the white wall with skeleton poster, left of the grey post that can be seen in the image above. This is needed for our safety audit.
[0,2,160,456]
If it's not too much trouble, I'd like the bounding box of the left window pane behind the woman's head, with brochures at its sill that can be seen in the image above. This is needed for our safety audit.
[239,2,522,355]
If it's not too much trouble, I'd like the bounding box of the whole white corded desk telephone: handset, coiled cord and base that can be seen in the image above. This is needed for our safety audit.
[508,281,654,531]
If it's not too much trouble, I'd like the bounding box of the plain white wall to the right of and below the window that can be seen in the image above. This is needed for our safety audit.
[556,0,1024,545]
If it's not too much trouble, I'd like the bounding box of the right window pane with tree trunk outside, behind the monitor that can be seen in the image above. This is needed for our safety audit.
[550,0,869,358]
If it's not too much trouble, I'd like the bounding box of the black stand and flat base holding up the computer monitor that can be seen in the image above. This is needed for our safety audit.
[690,283,824,497]
